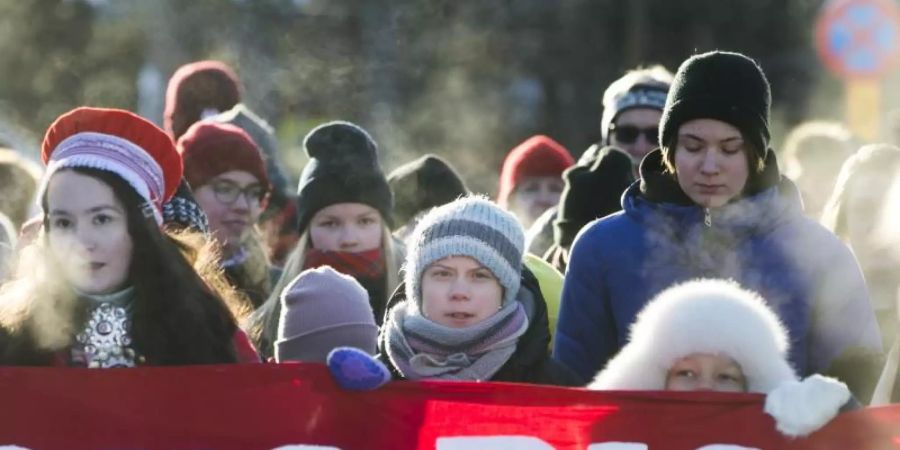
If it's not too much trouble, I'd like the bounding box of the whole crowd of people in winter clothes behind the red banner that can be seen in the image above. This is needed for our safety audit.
[0,51,900,435]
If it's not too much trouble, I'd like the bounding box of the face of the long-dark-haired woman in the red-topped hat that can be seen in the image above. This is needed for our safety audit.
[47,171,132,295]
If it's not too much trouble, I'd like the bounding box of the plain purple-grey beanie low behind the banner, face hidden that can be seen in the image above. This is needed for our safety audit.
[275,266,378,363]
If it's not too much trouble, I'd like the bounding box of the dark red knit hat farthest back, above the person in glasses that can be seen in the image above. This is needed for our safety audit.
[163,61,241,140]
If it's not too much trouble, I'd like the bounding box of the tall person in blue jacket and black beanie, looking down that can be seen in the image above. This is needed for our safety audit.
[553,51,881,398]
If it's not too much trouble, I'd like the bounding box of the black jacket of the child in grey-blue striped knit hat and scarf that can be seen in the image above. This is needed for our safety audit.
[378,267,585,386]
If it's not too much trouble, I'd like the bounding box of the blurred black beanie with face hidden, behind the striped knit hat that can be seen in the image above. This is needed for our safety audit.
[388,154,469,226]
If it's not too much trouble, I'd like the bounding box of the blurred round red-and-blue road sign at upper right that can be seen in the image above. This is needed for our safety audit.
[815,0,900,78]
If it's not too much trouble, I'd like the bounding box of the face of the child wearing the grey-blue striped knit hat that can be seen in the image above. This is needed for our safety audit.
[422,256,503,328]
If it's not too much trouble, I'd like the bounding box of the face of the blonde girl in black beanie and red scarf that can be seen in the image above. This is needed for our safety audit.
[309,203,384,253]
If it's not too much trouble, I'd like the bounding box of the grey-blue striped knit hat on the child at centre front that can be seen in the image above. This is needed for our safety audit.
[404,196,525,306]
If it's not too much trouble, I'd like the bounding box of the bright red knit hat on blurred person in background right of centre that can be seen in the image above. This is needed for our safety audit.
[497,134,575,208]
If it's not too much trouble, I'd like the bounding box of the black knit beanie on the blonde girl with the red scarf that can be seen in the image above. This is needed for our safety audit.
[297,121,393,233]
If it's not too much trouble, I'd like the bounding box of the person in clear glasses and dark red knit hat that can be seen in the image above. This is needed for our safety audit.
[177,121,280,308]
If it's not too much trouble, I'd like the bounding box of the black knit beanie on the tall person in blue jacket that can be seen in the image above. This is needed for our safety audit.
[659,51,772,159]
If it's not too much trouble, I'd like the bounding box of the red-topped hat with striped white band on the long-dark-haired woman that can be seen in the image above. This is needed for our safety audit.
[38,107,182,224]
